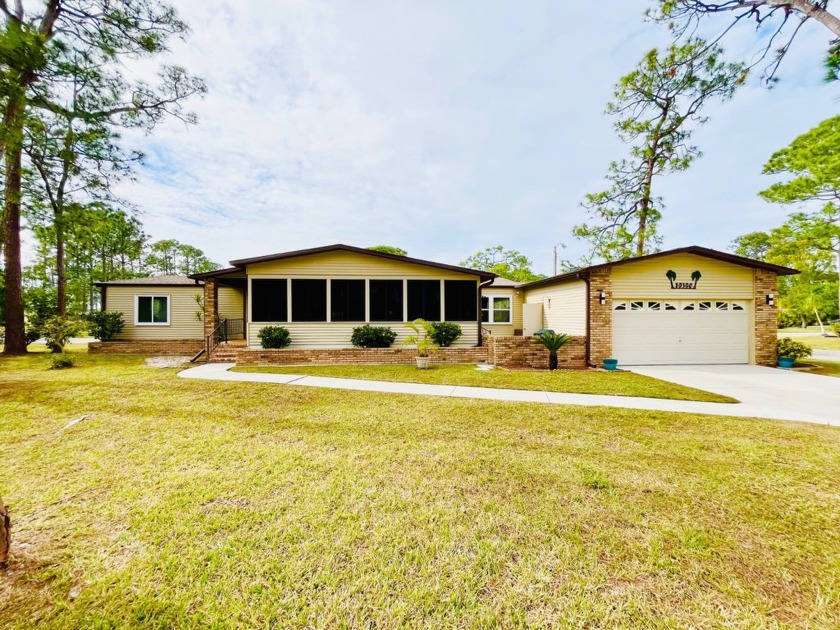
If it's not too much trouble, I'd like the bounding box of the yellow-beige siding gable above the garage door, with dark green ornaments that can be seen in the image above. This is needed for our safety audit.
[611,254,753,300]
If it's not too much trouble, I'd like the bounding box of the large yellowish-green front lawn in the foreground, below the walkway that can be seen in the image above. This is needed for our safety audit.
[0,355,840,628]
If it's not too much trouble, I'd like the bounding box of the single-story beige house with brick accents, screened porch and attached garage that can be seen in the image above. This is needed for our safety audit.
[95,245,798,367]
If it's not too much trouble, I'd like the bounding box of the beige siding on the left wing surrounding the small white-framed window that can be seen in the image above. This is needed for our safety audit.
[105,285,204,341]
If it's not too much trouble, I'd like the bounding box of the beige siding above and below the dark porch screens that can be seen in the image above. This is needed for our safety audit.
[247,251,478,348]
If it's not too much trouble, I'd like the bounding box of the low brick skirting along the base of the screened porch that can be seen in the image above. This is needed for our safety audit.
[236,348,487,365]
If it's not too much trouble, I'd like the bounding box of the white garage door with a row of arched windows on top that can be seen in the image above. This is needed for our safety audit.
[613,300,750,365]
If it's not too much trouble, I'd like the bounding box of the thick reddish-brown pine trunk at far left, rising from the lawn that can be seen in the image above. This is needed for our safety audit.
[3,103,26,355]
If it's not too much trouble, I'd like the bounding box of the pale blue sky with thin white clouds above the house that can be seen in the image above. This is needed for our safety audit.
[95,0,838,274]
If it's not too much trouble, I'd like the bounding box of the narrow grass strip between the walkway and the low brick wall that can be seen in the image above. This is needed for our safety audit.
[233,364,738,403]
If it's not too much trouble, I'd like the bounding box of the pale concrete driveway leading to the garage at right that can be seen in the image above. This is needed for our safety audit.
[626,365,840,426]
